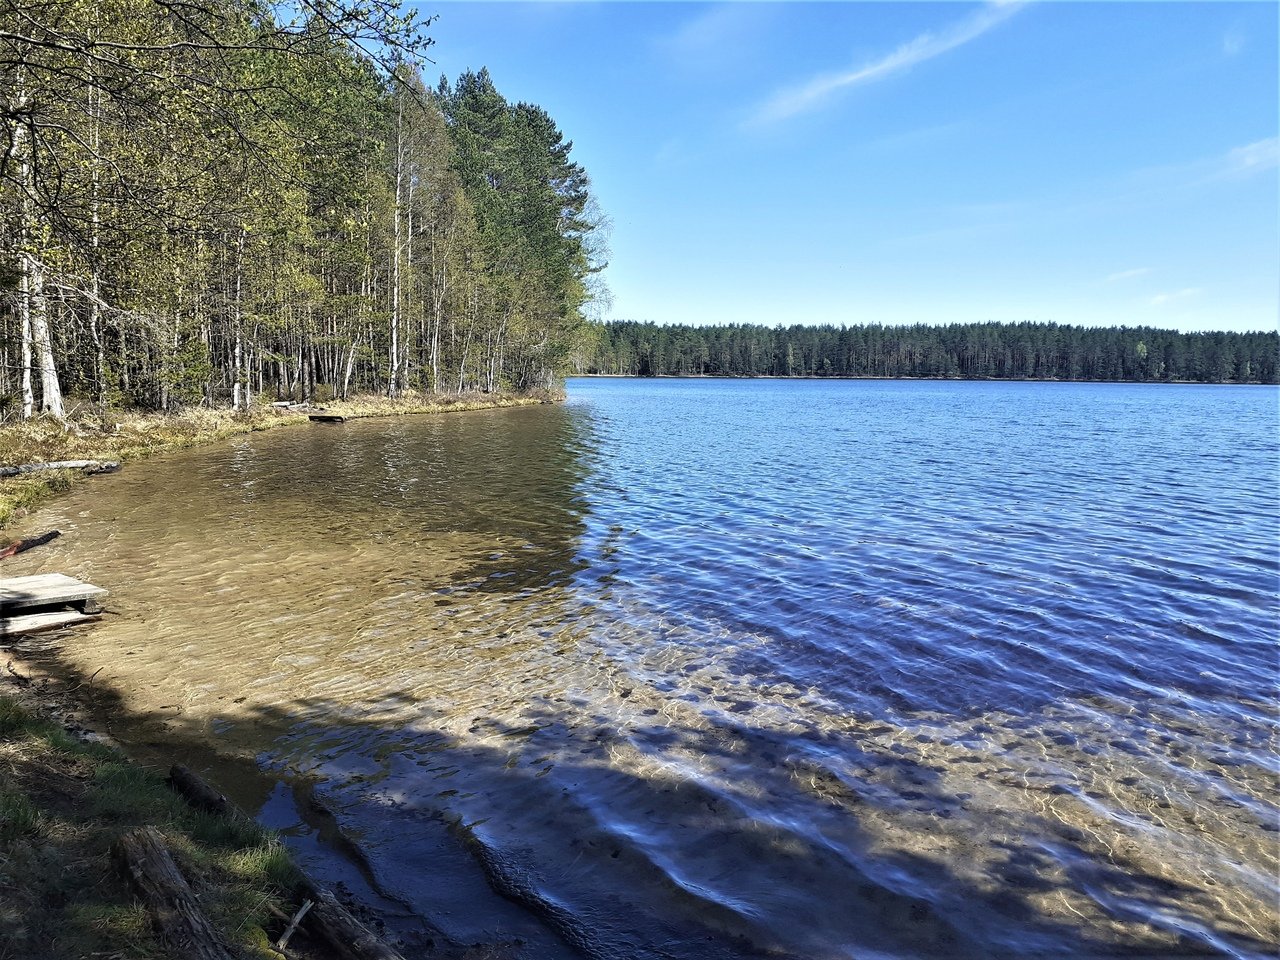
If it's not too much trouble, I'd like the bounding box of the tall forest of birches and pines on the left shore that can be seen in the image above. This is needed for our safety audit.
[0,0,605,419]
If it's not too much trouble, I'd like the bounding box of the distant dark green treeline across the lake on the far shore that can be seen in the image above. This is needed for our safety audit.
[577,320,1280,383]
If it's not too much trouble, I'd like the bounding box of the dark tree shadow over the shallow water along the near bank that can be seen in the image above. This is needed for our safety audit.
[17,652,1276,960]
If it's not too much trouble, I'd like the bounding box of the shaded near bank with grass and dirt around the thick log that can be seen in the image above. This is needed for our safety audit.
[0,648,448,960]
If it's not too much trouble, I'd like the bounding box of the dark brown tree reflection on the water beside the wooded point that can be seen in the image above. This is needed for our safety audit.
[269,406,590,593]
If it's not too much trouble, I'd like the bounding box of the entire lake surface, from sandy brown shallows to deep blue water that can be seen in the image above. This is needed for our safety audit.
[5,380,1280,960]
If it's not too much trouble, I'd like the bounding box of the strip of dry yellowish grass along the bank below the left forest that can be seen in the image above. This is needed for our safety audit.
[0,393,559,527]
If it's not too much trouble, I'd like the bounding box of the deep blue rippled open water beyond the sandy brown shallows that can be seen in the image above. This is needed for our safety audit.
[570,380,1280,727]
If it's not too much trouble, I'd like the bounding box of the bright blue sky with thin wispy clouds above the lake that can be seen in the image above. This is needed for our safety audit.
[421,3,1280,330]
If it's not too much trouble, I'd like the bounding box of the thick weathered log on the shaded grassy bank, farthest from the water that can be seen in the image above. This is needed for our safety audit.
[115,827,233,960]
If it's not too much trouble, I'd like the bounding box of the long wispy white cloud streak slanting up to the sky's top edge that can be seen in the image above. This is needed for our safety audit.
[750,3,1024,124]
